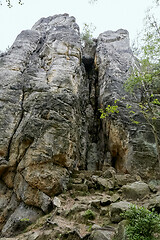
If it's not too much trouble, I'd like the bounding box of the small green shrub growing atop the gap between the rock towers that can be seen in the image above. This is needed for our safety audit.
[81,23,96,46]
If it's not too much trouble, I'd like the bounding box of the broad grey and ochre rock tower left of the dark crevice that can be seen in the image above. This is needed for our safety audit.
[0,14,82,236]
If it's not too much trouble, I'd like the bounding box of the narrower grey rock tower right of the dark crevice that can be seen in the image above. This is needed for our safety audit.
[95,29,159,178]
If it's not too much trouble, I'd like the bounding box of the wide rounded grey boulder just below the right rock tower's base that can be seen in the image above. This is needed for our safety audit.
[122,182,150,200]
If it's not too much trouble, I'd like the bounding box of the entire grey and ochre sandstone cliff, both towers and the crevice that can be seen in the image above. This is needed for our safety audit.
[0,14,158,236]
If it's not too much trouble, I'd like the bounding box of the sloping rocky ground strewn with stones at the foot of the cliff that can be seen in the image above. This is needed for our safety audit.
[1,167,160,240]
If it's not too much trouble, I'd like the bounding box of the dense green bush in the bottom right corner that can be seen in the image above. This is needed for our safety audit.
[122,205,160,240]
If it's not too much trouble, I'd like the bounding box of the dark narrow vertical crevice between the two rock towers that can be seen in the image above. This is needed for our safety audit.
[82,40,105,170]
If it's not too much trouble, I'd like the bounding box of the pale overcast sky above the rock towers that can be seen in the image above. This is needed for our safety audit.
[0,0,160,51]
